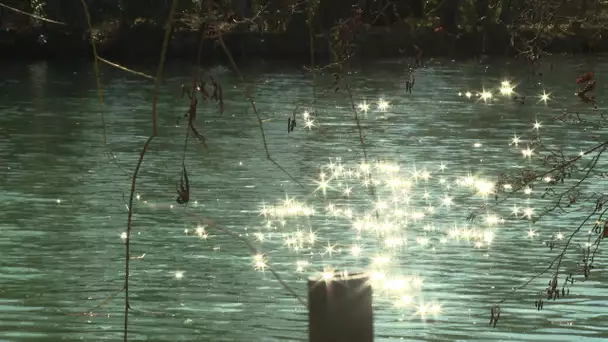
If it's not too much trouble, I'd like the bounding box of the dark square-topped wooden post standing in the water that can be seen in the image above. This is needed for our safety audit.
[308,274,374,342]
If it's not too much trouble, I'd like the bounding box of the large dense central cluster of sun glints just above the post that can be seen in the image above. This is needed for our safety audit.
[254,159,504,317]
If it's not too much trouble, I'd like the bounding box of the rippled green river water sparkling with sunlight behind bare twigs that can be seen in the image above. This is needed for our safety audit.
[0,58,608,341]
